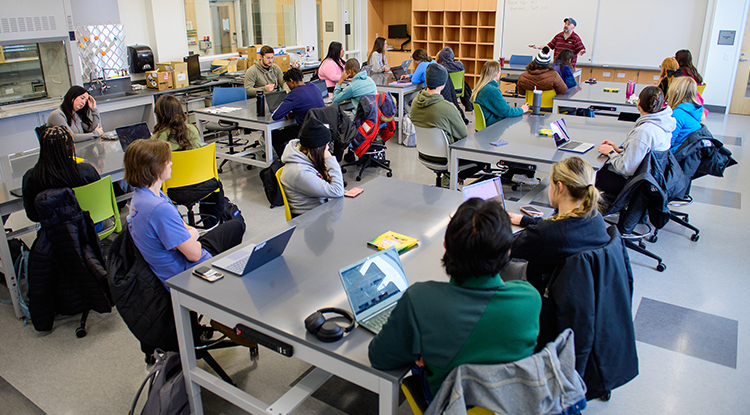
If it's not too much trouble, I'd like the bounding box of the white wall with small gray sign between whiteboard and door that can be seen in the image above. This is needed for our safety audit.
[704,0,750,108]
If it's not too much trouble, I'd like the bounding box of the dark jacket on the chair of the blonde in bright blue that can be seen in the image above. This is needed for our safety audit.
[674,125,737,190]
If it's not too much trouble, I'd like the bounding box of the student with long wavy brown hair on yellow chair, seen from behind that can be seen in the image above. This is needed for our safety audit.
[151,95,202,151]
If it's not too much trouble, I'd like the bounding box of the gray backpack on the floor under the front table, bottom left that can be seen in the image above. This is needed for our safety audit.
[129,349,190,415]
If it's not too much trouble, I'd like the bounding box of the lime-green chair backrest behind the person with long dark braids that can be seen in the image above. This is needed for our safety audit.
[73,176,122,239]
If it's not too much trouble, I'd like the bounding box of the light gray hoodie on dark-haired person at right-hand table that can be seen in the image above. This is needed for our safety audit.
[607,107,677,178]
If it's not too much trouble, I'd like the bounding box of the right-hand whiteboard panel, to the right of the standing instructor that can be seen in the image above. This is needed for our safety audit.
[584,0,707,67]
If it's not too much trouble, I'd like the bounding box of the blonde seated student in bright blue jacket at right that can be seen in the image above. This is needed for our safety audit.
[667,76,703,152]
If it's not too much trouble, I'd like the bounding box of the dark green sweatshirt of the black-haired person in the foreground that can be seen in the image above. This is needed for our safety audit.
[369,274,542,395]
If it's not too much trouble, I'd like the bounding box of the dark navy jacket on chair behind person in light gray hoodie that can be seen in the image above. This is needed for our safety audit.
[608,150,690,234]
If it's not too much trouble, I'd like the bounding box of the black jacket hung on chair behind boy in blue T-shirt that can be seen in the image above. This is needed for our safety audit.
[107,227,179,355]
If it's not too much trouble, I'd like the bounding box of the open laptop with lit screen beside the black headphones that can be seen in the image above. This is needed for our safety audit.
[339,247,409,334]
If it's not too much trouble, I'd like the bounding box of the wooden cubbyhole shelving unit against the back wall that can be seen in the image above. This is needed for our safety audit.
[412,0,497,87]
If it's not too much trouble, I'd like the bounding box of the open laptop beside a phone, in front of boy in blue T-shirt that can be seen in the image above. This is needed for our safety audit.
[212,226,297,276]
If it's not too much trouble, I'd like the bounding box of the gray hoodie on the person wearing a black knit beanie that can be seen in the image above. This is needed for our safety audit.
[281,139,344,215]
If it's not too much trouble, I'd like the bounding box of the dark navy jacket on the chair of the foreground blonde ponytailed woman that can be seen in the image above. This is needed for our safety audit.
[537,226,638,399]
